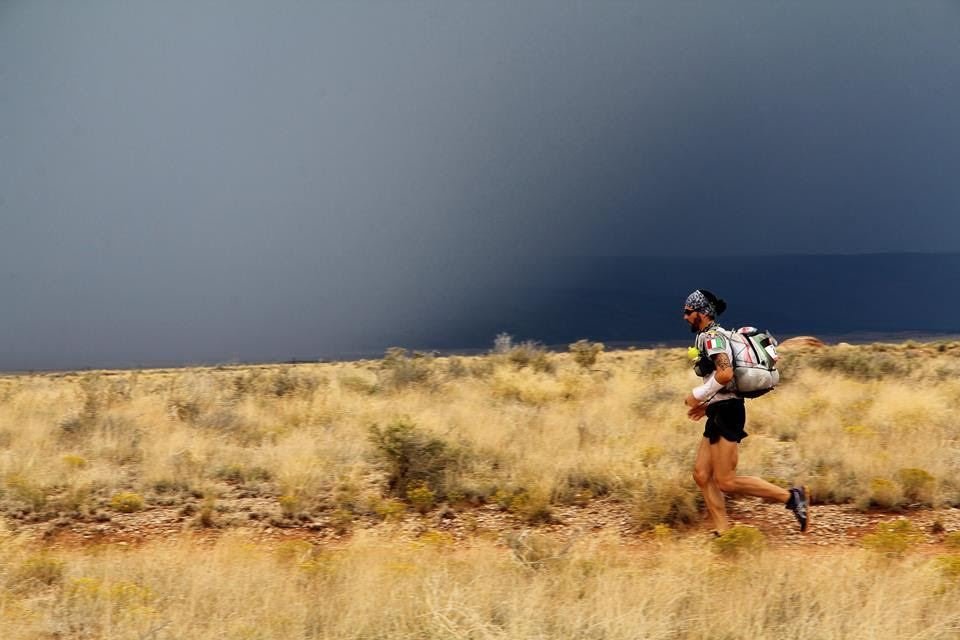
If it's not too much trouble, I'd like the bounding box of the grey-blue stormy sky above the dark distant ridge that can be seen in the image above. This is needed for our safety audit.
[0,0,960,369]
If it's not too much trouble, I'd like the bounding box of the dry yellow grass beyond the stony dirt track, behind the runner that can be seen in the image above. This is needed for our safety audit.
[0,344,960,525]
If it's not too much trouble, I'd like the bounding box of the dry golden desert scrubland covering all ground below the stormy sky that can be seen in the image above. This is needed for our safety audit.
[0,338,960,639]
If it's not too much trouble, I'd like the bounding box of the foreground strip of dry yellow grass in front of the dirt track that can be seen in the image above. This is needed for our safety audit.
[0,524,960,640]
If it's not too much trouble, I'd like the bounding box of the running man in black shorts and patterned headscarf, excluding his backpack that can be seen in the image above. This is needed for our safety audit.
[683,289,810,534]
